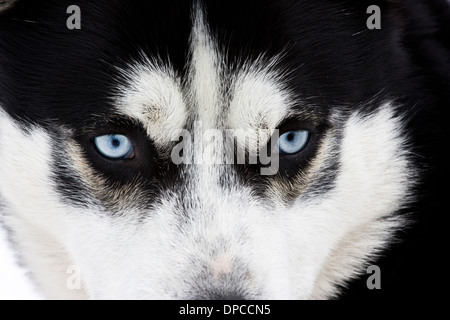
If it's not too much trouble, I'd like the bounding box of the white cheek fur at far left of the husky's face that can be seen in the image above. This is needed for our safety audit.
[0,109,87,298]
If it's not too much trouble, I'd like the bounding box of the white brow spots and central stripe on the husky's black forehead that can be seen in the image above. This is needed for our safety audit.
[114,5,296,145]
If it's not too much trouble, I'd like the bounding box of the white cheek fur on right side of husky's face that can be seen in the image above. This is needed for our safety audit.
[312,103,414,298]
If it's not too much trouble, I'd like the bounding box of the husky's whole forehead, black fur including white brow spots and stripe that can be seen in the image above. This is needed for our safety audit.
[0,0,390,126]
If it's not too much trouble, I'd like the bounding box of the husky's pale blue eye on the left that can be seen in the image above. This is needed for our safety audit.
[94,134,133,160]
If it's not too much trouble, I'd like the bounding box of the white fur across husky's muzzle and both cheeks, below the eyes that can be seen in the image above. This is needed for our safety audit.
[0,104,408,299]
